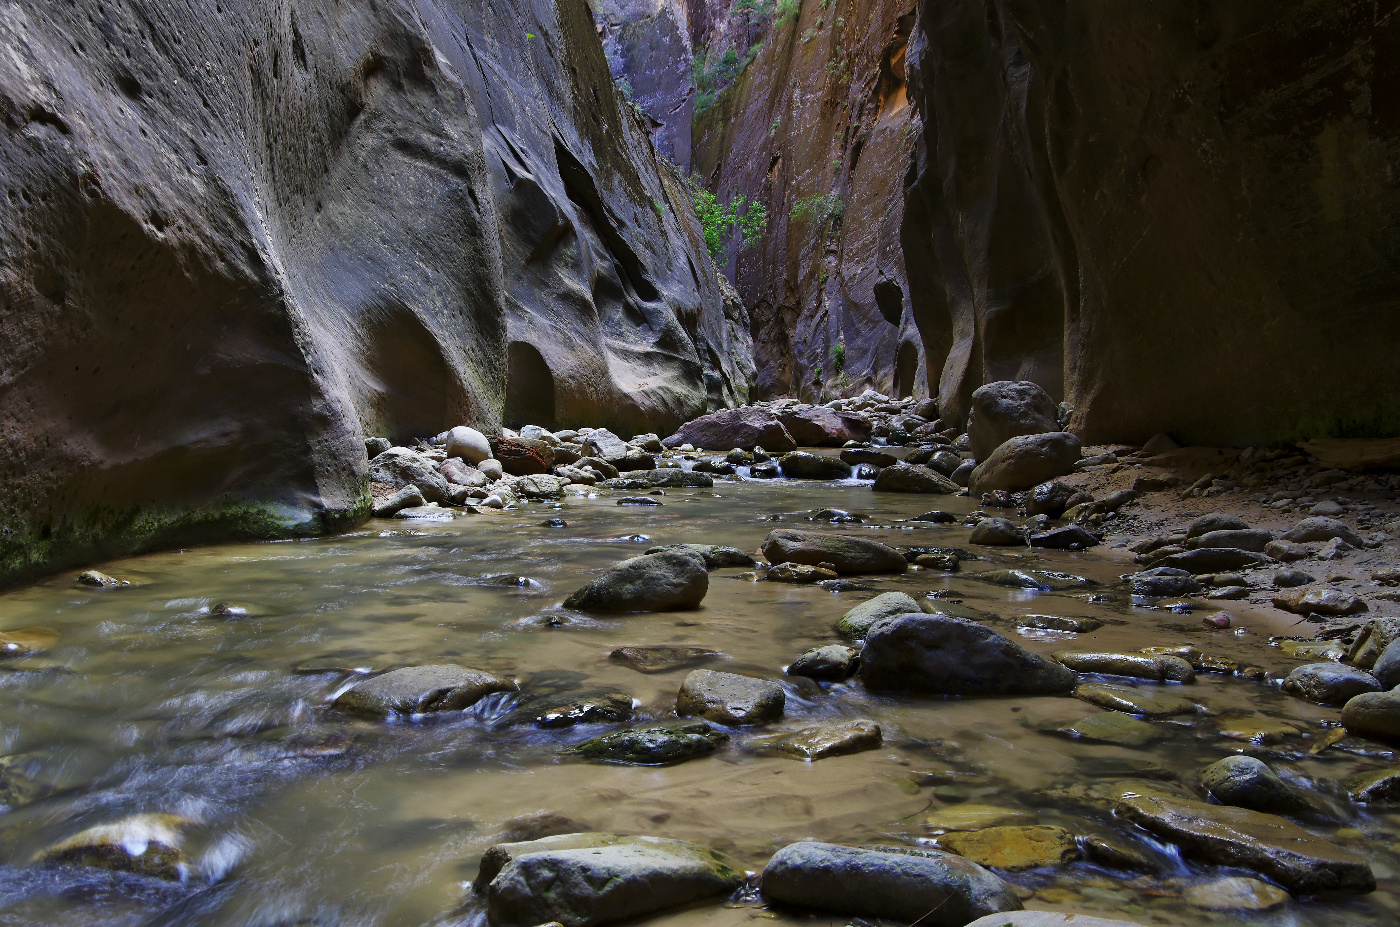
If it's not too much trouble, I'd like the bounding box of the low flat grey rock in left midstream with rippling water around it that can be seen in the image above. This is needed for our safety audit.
[332,664,519,718]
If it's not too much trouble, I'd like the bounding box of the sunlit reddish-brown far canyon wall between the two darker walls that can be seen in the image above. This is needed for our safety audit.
[693,0,928,399]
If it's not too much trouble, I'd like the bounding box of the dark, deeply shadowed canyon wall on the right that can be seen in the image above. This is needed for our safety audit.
[903,0,1400,447]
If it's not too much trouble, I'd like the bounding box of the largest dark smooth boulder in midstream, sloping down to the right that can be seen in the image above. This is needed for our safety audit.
[860,613,1078,696]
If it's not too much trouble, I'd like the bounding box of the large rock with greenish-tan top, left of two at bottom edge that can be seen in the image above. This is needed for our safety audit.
[483,835,743,927]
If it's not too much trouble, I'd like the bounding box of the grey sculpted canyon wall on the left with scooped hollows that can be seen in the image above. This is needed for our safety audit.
[0,0,752,583]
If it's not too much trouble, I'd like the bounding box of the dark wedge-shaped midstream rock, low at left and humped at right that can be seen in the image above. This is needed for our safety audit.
[564,550,710,612]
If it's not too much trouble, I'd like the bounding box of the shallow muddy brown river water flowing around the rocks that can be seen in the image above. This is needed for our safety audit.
[0,480,1400,927]
